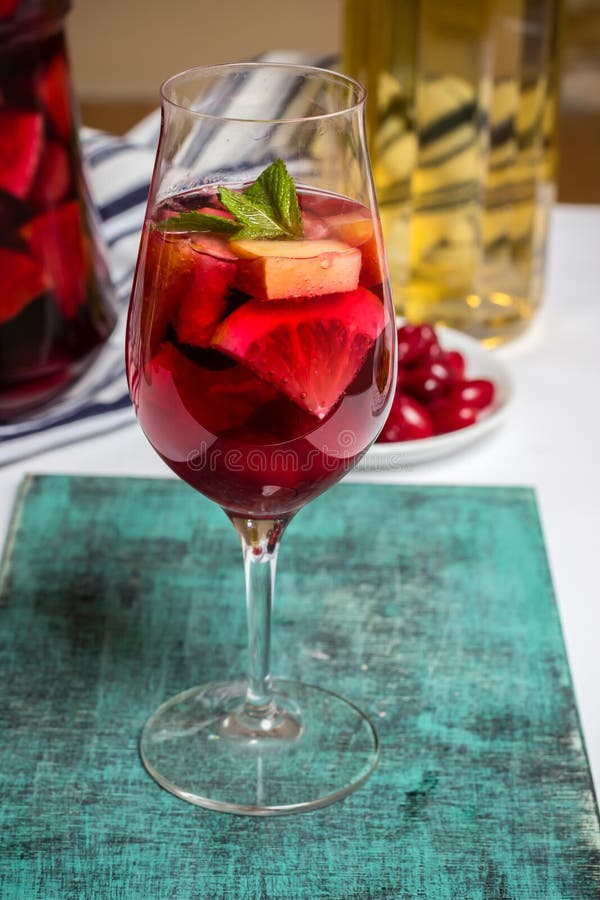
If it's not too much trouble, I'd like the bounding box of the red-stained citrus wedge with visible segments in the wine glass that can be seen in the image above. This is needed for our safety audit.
[211,287,386,419]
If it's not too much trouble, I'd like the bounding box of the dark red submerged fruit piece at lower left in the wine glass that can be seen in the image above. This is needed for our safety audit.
[140,344,277,440]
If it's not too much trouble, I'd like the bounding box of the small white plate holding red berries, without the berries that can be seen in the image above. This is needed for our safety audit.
[358,326,512,470]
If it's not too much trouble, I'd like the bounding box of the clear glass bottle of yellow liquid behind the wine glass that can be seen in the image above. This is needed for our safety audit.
[344,0,561,346]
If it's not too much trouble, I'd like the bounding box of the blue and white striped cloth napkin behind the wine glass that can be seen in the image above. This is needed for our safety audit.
[0,51,334,465]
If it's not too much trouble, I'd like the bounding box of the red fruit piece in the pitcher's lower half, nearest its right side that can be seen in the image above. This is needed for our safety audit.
[19,200,86,318]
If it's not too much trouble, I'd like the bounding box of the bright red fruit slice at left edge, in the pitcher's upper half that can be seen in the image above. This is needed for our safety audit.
[0,109,44,200]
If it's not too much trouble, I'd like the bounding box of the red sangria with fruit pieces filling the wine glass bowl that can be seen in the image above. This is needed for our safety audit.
[130,179,393,517]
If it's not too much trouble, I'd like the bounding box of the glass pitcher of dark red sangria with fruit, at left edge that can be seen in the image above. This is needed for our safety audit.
[0,0,116,422]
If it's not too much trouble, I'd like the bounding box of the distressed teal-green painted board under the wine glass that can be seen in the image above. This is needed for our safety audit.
[0,477,600,900]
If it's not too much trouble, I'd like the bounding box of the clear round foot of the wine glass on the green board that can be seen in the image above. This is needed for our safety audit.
[140,679,379,816]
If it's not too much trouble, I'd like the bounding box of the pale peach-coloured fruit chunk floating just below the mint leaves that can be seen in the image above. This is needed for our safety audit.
[229,240,361,300]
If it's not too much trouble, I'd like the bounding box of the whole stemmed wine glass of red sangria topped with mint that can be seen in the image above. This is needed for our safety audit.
[127,63,396,815]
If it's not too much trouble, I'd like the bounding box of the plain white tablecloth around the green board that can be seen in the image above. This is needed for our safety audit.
[0,206,600,786]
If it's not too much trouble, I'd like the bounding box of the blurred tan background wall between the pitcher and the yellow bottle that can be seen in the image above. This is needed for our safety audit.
[67,0,343,102]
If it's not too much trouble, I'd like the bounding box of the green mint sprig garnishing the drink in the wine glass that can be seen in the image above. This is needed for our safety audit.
[157,159,303,240]
